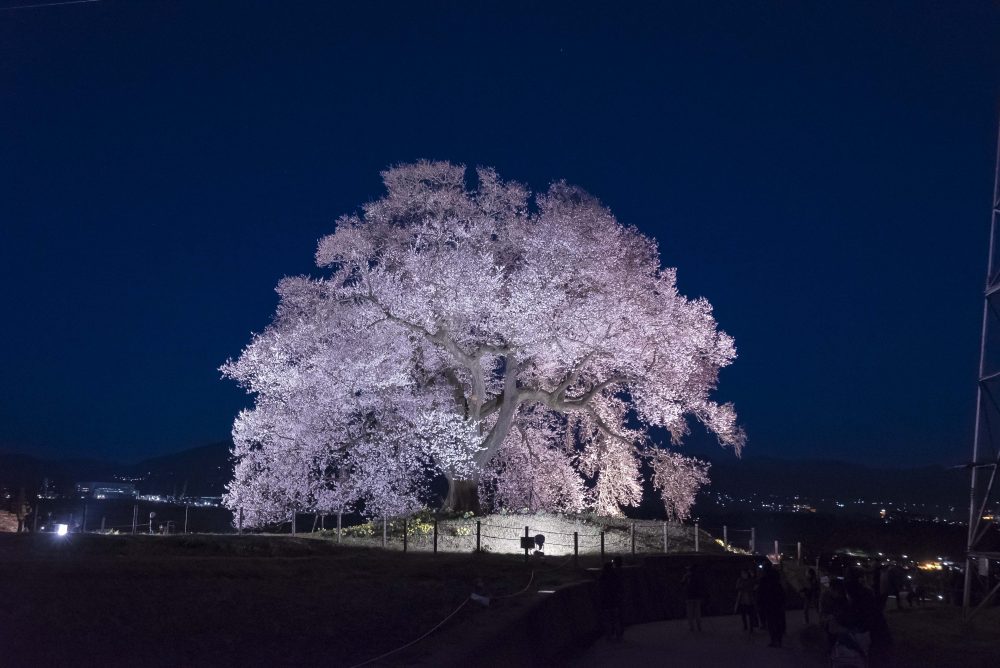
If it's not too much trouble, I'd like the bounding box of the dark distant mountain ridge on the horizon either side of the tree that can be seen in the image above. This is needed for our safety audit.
[0,441,968,506]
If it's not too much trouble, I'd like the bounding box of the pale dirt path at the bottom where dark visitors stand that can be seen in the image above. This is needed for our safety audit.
[573,612,829,668]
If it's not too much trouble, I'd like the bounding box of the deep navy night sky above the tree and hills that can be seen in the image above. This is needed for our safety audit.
[0,0,1000,465]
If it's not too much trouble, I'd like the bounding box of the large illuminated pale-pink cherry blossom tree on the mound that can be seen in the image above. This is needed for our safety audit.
[223,162,744,516]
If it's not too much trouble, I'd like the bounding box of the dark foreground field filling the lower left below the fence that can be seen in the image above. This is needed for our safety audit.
[0,534,586,668]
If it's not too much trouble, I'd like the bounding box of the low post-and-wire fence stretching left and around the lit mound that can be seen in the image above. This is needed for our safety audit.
[34,501,805,561]
